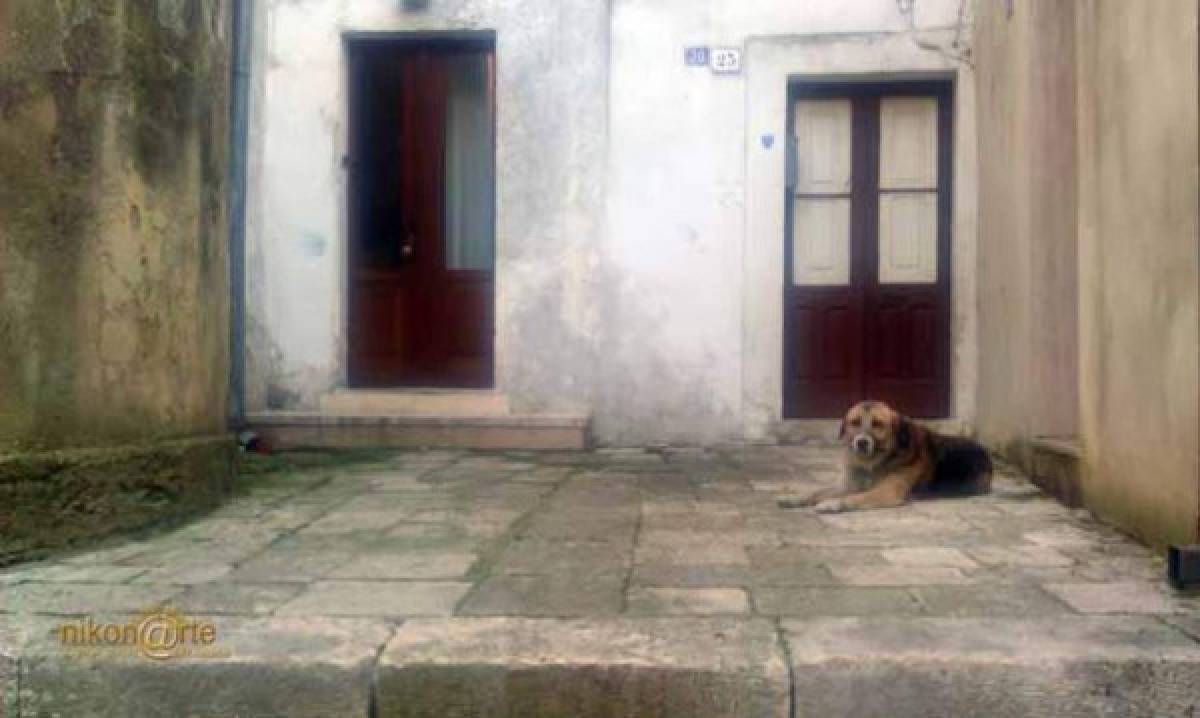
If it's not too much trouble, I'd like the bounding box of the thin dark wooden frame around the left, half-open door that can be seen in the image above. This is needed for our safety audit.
[338,30,500,391]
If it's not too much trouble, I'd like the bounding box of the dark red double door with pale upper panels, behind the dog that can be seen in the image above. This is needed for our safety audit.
[784,83,952,418]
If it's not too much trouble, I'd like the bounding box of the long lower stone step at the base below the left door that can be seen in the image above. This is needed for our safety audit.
[246,412,590,450]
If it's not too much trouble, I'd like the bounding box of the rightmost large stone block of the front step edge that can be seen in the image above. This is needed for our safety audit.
[784,616,1200,718]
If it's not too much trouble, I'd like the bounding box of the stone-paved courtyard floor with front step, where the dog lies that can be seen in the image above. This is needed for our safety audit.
[0,447,1200,717]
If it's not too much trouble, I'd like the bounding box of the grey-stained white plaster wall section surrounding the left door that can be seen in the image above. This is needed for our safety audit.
[246,0,608,411]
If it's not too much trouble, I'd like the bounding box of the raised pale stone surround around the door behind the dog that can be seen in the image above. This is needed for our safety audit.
[740,32,979,443]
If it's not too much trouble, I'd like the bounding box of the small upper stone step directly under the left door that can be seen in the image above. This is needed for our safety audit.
[320,389,509,417]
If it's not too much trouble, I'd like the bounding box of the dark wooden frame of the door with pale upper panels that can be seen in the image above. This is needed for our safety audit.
[780,77,955,420]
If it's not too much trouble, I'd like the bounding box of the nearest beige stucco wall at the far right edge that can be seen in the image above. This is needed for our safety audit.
[1076,0,1200,543]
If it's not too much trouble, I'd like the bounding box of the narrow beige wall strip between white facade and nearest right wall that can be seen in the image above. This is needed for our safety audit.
[976,1,1079,463]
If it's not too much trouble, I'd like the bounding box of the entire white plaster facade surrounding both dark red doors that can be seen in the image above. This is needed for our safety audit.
[247,0,974,445]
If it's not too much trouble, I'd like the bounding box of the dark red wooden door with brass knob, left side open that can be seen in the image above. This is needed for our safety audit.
[347,44,494,388]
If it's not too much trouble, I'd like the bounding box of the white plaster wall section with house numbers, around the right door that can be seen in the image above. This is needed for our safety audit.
[595,0,977,444]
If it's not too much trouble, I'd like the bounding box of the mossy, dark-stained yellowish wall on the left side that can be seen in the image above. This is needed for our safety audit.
[0,0,230,560]
